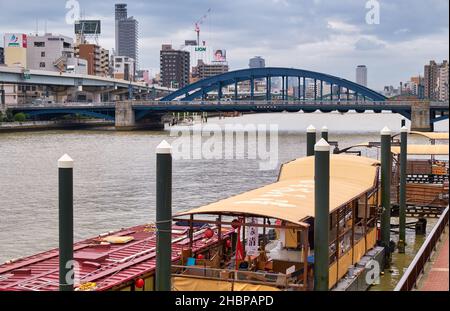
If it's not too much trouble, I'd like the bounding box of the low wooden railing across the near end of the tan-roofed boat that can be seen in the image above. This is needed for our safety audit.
[172,265,307,290]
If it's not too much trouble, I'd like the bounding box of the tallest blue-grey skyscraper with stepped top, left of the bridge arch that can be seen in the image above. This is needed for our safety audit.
[115,3,139,67]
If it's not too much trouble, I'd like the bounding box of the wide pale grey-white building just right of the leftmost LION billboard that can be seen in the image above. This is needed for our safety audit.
[27,33,87,74]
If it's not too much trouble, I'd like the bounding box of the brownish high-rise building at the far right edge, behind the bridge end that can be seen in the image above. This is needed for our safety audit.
[424,60,448,100]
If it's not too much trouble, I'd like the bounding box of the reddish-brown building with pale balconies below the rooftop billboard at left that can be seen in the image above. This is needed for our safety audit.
[75,44,109,77]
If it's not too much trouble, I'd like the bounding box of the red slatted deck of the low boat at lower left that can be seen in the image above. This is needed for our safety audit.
[0,226,233,291]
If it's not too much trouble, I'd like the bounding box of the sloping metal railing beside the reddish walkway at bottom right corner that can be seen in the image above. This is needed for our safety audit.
[394,206,449,292]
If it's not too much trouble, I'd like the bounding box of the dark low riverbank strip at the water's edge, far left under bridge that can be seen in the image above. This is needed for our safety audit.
[0,120,114,133]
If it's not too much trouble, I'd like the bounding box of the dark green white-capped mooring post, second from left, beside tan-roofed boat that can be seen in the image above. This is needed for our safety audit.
[155,140,172,291]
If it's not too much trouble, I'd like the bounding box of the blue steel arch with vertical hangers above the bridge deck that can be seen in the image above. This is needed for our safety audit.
[161,67,386,101]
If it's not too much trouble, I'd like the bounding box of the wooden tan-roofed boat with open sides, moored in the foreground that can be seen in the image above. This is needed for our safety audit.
[172,155,379,291]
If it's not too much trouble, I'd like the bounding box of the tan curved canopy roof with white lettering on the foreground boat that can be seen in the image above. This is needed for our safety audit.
[178,155,379,225]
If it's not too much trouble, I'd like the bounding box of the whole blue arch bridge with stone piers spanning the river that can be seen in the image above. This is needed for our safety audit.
[11,68,449,131]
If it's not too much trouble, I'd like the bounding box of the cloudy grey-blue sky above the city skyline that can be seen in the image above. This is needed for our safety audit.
[0,0,449,89]
